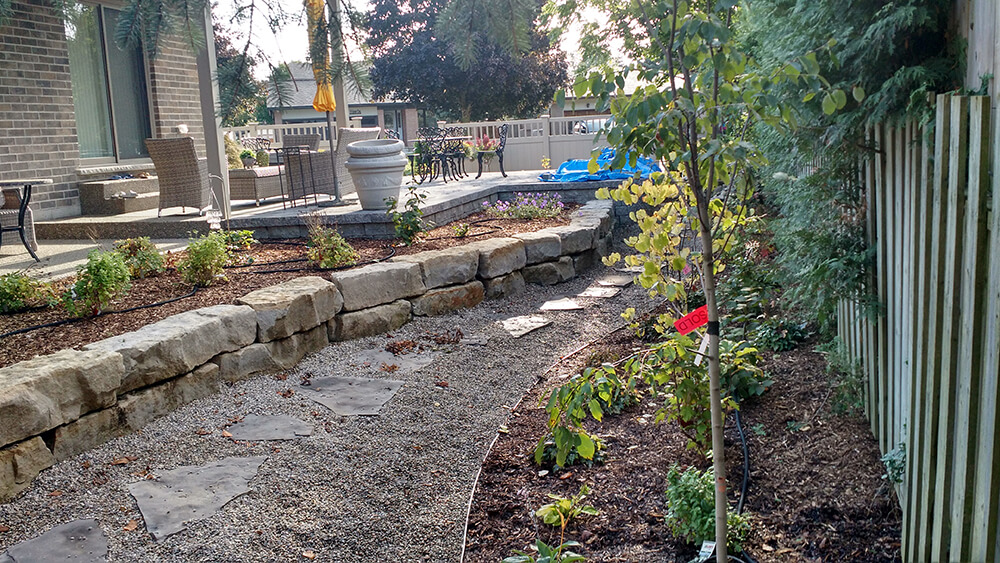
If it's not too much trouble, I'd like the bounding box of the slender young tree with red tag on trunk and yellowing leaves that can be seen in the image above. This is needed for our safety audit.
[574,0,847,563]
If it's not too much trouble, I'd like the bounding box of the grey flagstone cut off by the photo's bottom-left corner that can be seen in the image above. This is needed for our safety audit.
[0,518,108,563]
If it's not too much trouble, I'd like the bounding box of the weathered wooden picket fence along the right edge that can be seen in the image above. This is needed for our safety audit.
[838,95,1000,561]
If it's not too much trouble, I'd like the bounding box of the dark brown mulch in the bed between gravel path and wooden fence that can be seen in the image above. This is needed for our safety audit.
[466,336,900,563]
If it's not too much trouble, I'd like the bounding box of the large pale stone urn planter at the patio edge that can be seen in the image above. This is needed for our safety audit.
[345,139,406,209]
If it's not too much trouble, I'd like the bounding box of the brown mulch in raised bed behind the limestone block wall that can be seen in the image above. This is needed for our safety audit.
[0,206,578,367]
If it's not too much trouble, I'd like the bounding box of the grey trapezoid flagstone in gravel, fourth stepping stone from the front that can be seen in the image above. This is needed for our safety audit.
[301,377,403,416]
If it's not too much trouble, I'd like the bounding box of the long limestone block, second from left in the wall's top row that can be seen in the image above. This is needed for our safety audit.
[84,305,257,395]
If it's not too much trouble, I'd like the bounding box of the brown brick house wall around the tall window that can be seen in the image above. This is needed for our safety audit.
[0,0,211,221]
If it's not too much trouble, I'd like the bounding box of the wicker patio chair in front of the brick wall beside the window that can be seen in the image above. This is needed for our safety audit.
[146,137,212,217]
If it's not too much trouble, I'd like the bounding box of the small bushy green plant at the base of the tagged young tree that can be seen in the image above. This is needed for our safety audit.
[664,464,750,552]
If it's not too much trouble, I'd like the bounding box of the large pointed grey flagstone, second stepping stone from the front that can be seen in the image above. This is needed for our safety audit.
[128,456,267,541]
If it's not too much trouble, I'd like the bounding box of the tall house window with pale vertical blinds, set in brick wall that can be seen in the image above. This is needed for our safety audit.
[66,4,152,162]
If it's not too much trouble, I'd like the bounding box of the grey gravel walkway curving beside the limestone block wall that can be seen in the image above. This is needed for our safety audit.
[0,266,645,562]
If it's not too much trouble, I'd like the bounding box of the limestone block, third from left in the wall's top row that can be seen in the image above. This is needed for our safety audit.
[236,276,344,342]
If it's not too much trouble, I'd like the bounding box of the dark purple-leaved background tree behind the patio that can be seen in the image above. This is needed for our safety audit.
[367,0,567,121]
